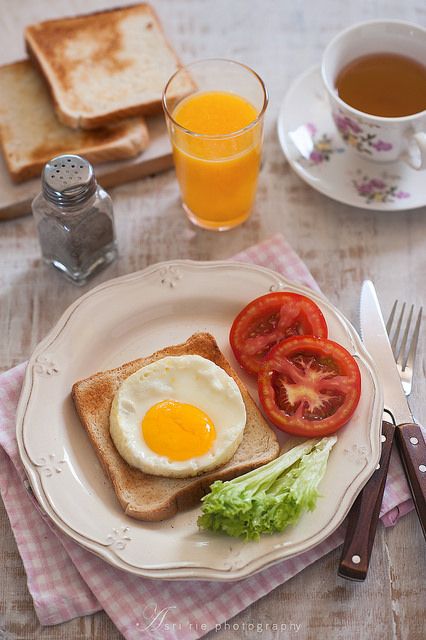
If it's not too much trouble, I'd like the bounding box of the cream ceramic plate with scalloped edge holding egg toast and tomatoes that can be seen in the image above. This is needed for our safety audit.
[17,261,383,580]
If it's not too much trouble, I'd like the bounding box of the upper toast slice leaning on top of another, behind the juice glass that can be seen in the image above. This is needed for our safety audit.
[25,3,193,128]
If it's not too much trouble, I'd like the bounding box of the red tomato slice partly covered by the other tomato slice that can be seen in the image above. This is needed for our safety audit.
[229,291,328,374]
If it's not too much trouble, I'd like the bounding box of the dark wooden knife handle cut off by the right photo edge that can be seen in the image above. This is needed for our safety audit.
[396,423,426,538]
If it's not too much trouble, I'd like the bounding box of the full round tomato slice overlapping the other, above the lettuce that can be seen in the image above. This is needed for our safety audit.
[258,336,361,437]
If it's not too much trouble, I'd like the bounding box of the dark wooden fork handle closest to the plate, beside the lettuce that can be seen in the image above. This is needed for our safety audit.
[338,421,395,581]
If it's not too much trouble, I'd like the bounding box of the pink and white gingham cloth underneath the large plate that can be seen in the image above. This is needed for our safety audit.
[0,235,420,640]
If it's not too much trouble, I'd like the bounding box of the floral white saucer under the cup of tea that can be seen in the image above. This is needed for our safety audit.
[278,67,426,211]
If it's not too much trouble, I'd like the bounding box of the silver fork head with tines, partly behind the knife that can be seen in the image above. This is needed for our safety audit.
[386,300,423,396]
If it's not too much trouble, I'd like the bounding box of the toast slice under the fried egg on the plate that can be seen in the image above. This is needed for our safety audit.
[72,333,279,521]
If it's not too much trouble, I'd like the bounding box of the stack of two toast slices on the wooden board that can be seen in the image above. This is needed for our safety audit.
[0,3,192,182]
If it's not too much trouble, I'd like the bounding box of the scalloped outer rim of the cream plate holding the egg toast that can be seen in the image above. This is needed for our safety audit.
[16,260,383,581]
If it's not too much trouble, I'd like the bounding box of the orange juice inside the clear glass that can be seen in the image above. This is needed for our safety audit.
[172,91,262,229]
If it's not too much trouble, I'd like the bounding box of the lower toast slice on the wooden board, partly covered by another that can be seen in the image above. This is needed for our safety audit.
[0,60,149,182]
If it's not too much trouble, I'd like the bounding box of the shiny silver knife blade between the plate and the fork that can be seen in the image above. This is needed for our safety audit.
[360,280,413,424]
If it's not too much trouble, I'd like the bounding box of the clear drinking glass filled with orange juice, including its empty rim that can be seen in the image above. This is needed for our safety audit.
[163,59,268,231]
